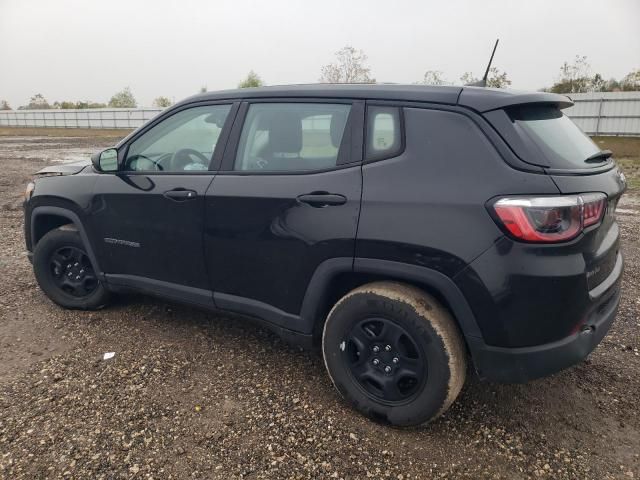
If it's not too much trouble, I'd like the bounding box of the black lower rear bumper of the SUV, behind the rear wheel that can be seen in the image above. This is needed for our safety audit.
[468,257,622,383]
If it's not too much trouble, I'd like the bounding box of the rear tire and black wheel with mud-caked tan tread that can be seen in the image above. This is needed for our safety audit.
[322,282,467,426]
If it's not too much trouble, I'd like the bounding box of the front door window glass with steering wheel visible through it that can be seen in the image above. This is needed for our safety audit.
[125,105,231,172]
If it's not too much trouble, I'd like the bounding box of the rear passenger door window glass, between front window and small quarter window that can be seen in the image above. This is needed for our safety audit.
[234,103,351,171]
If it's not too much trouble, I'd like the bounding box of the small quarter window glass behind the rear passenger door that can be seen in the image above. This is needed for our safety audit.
[367,107,402,160]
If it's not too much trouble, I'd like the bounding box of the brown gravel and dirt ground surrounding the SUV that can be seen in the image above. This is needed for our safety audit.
[0,130,640,479]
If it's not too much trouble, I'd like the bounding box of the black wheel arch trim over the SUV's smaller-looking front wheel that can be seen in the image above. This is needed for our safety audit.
[30,206,102,277]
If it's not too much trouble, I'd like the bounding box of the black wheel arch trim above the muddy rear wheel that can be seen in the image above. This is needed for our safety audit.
[300,258,482,345]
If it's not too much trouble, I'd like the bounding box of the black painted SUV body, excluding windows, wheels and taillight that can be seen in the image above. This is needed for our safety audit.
[25,86,624,381]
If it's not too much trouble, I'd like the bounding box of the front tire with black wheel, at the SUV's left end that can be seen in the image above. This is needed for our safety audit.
[33,226,109,310]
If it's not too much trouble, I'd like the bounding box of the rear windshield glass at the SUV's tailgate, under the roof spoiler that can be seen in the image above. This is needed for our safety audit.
[508,105,607,169]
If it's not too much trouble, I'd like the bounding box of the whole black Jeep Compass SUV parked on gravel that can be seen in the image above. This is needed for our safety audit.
[25,85,625,425]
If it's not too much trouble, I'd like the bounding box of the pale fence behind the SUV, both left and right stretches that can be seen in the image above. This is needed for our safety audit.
[0,92,640,136]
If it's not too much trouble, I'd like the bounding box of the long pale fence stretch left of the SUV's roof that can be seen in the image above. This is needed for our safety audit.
[0,108,162,128]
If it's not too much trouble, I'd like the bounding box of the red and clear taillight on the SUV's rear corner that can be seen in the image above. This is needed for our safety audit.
[493,193,607,243]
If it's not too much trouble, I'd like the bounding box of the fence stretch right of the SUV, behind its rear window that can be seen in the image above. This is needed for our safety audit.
[564,92,640,136]
